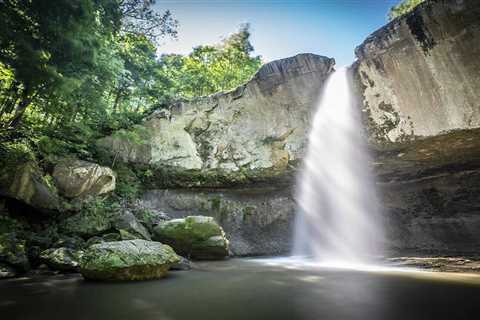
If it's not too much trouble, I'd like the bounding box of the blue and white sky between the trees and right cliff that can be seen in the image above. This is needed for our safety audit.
[155,0,399,66]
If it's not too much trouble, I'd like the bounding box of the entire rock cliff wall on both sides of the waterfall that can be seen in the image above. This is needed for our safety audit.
[98,0,480,255]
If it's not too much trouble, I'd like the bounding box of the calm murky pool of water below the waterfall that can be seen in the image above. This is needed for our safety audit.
[0,259,480,320]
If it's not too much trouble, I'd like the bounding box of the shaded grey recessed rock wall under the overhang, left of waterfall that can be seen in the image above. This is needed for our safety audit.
[142,186,295,256]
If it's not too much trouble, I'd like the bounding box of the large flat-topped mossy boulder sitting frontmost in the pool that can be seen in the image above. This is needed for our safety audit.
[80,240,180,280]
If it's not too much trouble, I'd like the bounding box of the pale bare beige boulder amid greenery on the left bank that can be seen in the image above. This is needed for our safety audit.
[53,159,115,198]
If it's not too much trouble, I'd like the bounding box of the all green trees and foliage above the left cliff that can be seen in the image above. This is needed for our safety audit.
[0,0,260,159]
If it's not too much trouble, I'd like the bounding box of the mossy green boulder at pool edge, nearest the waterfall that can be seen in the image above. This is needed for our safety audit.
[154,216,229,260]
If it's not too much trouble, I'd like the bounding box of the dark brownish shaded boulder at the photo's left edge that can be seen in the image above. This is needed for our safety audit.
[0,161,59,212]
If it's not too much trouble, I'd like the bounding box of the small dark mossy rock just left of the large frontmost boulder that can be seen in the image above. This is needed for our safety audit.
[40,247,83,271]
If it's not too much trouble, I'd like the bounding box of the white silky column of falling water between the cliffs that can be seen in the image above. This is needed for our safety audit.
[294,68,382,265]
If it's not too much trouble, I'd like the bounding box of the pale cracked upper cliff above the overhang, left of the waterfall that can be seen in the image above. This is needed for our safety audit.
[98,54,334,187]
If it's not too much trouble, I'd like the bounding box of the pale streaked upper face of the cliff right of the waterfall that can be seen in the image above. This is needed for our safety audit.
[355,0,480,146]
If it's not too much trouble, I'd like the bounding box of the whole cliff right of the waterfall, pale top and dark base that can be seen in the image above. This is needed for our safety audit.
[353,0,480,254]
